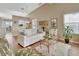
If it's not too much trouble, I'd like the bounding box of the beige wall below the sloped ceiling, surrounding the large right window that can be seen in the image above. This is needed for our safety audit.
[28,3,79,41]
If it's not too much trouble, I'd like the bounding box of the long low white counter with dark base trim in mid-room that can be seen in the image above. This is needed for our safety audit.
[18,32,45,47]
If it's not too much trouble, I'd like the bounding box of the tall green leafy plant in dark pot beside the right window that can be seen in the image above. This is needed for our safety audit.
[63,25,73,44]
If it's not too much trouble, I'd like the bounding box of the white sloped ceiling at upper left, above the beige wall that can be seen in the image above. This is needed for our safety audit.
[0,3,43,19]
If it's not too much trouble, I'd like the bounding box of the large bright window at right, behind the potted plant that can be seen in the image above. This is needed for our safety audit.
[64,12,79,34]
